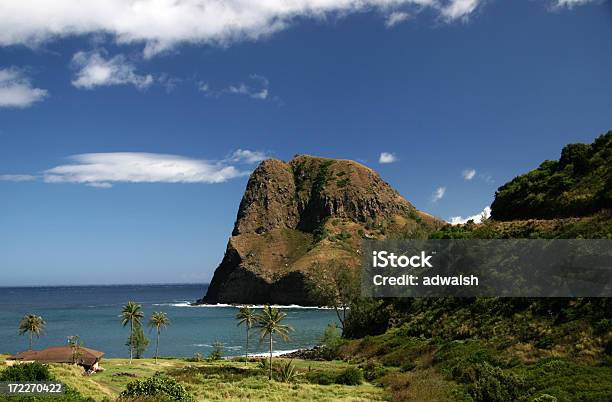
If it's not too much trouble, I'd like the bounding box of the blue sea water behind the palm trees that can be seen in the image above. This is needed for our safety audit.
[0,285,336,357]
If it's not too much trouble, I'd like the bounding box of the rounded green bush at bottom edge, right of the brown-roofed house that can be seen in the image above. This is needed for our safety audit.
[120,374,195,402]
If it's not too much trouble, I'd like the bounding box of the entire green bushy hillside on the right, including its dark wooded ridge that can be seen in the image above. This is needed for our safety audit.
[336,132,612,402]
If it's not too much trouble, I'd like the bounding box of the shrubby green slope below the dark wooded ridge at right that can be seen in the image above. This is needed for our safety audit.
[341,211,612,402]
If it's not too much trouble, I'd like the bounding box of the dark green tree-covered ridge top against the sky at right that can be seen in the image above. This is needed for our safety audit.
[491,131,612,220]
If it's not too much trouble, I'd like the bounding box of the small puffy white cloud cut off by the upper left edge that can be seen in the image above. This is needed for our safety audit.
[0,68,48,108]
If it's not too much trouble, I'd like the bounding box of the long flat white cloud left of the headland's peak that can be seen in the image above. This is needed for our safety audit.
[43,150,257,188]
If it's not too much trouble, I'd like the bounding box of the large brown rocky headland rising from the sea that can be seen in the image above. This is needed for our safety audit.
[200,155,443,305]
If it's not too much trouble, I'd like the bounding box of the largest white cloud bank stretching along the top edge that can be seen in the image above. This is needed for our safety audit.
[0,0,482,56]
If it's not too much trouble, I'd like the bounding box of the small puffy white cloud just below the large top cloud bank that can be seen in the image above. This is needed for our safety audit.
[72,50,153,89]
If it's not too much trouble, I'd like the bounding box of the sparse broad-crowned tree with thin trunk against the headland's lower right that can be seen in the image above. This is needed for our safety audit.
[308,260,361,333]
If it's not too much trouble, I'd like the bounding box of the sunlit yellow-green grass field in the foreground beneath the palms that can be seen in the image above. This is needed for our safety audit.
[0,356,385,402]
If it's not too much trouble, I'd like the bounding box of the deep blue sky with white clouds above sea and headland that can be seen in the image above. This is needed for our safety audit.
[0,0,612,286]
